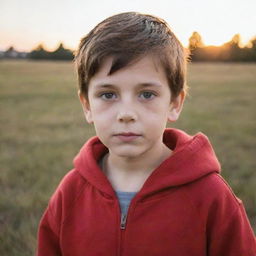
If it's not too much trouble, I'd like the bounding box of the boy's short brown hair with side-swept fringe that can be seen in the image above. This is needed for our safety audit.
[75,12,187,98]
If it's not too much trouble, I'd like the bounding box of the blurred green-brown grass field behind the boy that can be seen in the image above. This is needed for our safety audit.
[0,61,256,256]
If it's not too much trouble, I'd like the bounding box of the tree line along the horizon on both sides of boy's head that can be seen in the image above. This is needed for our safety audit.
[0,32,256,62]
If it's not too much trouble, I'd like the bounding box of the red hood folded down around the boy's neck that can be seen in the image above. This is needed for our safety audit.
[74,129,220,199]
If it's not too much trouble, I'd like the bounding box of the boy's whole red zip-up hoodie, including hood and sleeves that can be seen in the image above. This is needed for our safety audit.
[37,129,256,256]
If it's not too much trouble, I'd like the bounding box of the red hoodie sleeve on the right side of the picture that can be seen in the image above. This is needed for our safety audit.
[207,177,256,256]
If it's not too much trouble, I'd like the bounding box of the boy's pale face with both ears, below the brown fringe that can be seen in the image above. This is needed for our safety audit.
[80,55,184,158]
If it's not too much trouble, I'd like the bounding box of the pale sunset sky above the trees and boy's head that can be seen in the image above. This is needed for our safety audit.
[0,0,256,51]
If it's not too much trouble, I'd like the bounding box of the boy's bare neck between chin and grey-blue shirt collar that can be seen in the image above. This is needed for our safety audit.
[102,144,172,192]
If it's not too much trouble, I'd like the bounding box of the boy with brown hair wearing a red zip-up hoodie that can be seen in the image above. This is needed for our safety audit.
[38,12,256,256]
